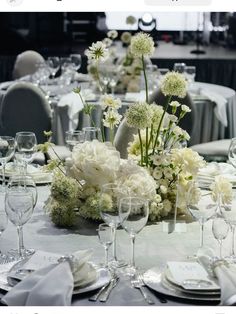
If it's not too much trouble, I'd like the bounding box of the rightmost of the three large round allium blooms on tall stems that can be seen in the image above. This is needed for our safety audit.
[161,72,187,98]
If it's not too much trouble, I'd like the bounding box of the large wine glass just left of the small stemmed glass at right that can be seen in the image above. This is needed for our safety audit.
[187,182,217,248]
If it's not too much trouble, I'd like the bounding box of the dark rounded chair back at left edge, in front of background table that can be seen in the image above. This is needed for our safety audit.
[1,82,52,143]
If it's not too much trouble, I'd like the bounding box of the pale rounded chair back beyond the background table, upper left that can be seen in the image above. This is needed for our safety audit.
[12,50,45,79]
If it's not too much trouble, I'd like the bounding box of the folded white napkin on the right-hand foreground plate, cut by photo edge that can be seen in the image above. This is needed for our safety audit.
[198,249,236,305]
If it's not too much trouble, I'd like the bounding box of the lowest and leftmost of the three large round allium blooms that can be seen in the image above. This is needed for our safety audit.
[125,102,152,129]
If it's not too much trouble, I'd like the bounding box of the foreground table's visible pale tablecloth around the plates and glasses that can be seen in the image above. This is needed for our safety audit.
[1,186,230,306]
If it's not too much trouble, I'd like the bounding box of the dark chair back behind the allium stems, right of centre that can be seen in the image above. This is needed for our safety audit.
[149,90,197,145]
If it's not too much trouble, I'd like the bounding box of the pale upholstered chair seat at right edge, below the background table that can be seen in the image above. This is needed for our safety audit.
[190,139,231,162]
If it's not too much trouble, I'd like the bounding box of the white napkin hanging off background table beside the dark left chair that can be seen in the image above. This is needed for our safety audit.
[57,92,84,130]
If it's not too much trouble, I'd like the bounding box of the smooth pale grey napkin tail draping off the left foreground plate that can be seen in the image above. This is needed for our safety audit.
[2,261,74,306]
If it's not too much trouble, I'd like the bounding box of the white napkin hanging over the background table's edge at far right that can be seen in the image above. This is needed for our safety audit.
[200,88,228,127]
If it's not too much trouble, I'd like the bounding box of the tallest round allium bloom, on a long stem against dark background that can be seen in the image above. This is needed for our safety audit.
[130,32,155,57]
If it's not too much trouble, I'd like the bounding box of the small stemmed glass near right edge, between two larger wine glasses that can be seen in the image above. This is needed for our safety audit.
[212,215,229,259]
